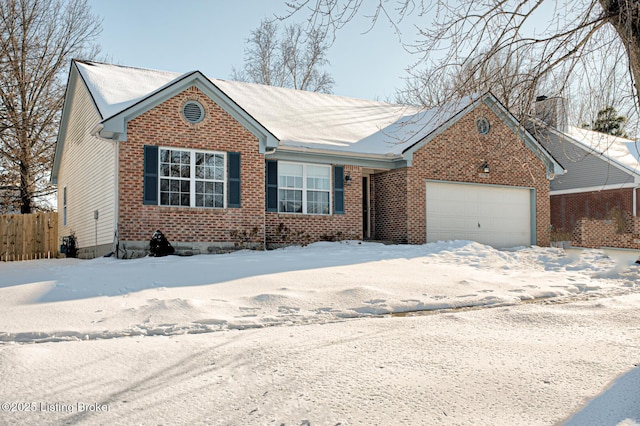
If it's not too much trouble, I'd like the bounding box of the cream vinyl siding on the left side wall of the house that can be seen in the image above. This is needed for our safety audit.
[58,80,116,248]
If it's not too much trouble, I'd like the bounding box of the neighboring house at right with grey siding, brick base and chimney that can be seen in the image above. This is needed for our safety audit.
[529,98,640,248]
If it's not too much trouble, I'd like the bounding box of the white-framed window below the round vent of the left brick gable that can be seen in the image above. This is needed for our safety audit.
[158,148,227,208]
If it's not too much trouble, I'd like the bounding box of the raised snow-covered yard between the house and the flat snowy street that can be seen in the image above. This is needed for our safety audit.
[0,241,640,342]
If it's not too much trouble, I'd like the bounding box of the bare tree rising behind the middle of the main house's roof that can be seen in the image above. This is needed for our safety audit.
[232,20,334,93]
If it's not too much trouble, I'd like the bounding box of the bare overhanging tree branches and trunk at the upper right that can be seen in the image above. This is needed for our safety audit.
[287,0,640,120]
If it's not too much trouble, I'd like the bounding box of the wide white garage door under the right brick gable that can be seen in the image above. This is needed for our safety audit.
[427,182,532,248]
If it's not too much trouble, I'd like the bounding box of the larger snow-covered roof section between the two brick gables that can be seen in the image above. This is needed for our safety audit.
[213,80,471,155]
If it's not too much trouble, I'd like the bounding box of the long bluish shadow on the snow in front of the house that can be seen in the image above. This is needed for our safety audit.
[0,241,450,303]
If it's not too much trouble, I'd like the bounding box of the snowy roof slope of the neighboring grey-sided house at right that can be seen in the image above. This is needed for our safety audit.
[565,126,640,173]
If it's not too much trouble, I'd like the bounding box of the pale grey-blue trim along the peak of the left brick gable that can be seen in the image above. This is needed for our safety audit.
[100,71,278,149]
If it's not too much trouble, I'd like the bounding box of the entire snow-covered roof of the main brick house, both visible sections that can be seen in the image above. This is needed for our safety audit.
[75,61,473,156]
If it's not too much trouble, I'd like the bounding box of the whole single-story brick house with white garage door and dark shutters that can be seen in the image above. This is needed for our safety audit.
[52,61,563,257]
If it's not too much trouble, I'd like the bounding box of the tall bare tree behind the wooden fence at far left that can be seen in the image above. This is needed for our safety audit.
[0,0,101,213]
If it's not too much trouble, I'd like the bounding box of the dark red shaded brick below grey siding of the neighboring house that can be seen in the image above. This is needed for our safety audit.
[551,188,634,232]
